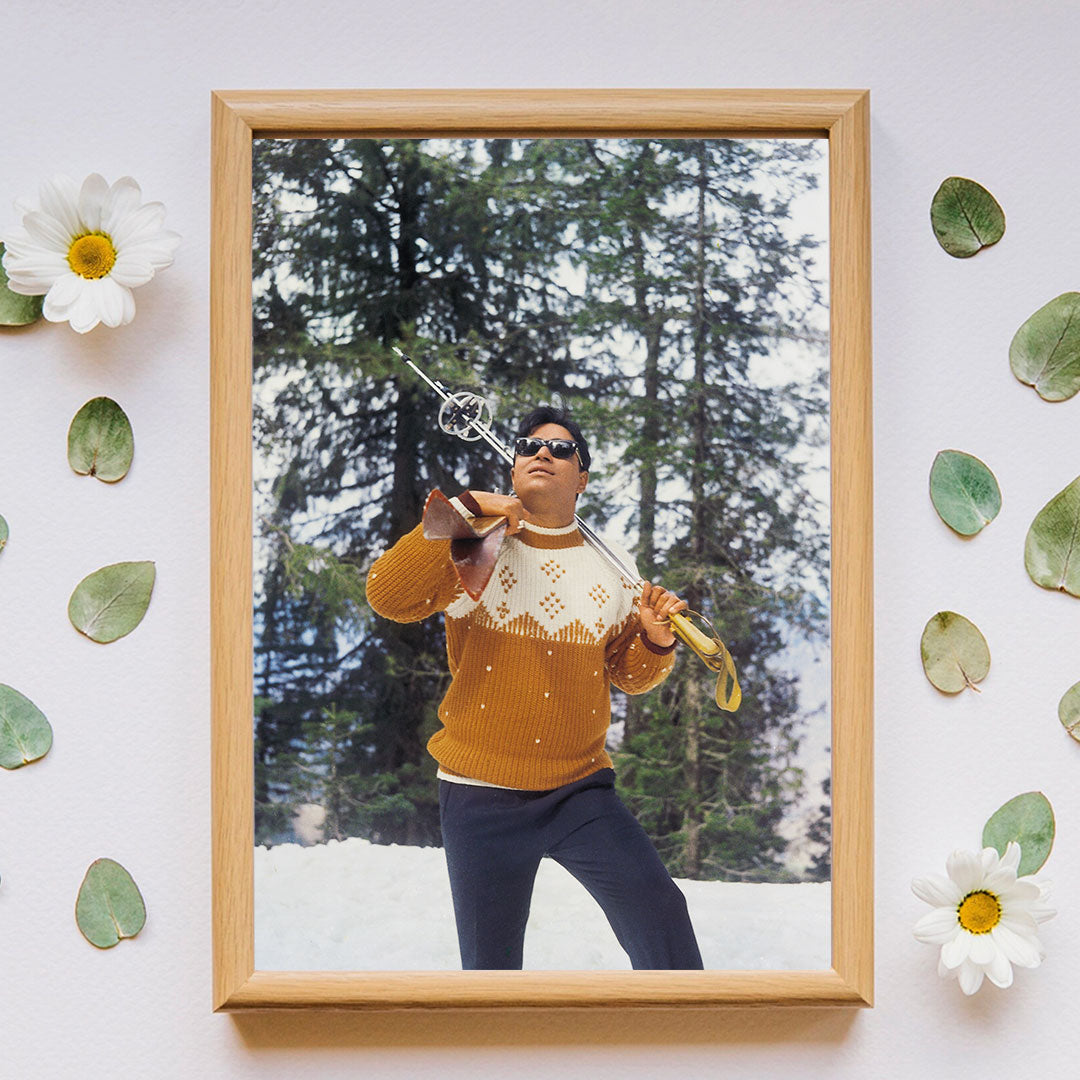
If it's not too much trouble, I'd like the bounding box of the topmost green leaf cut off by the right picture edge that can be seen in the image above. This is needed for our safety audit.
[1009,293,1080,402]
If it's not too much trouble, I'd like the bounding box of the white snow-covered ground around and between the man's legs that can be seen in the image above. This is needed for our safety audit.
[255,838,831,971]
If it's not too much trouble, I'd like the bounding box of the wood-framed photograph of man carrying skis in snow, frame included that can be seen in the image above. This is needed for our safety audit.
[211,90,874,1010]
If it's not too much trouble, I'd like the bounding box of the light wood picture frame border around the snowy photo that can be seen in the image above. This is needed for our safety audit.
[211,90,874,1011]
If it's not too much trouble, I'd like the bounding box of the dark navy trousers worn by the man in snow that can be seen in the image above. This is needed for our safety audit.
[438,769,702,970]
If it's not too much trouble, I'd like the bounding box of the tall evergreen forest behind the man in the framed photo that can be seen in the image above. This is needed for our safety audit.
[253,138,829,881]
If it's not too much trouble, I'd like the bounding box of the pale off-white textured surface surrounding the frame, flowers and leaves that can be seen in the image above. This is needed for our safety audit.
[0,0,1080,1080]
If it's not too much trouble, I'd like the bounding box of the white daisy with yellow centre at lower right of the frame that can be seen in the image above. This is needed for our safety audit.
[912,843,1055,994]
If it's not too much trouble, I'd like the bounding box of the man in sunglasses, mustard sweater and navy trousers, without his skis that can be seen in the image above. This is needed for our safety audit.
[367,407,702,969]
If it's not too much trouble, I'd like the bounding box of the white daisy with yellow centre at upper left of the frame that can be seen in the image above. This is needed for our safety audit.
[0,173,180,334]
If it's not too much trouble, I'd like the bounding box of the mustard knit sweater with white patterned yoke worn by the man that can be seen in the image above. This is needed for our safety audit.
[367,503,674,791]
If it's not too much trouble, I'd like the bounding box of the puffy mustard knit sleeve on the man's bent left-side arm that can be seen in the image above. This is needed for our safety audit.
[367,524,462,622]
